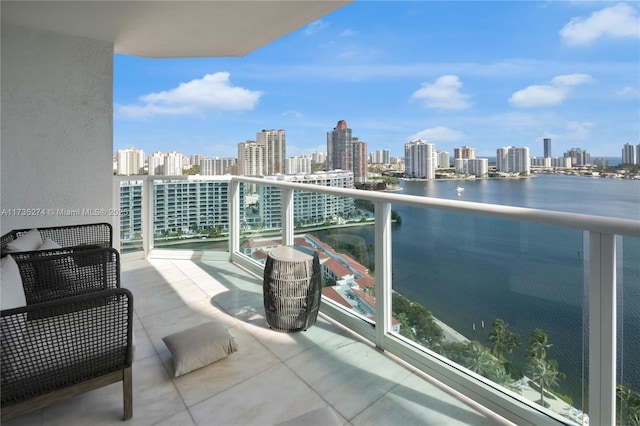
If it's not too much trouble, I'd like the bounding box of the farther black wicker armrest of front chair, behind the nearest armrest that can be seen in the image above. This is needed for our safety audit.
[12,248,120,305]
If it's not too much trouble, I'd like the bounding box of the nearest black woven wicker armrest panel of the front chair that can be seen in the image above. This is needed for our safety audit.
[0,289,133,406]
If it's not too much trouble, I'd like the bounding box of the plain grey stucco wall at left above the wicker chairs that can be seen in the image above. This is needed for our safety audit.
[0,25,113,234]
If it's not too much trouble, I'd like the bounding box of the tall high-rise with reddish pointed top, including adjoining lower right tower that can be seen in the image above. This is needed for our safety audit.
[327,120,367,183]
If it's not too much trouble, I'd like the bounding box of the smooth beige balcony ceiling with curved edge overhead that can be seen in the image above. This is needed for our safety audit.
[1,0,352,58]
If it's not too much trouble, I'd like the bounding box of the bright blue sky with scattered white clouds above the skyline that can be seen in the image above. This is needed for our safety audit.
[114,1,640,157]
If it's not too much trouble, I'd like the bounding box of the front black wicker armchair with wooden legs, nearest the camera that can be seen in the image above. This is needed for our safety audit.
[0,242,133,421]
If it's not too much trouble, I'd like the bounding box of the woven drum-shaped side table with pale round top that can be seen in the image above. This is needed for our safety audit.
[262,246,322,331]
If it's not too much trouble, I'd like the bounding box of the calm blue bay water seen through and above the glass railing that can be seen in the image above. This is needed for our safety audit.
[319,175,640,407]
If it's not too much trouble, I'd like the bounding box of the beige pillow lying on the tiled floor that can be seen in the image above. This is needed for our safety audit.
[162,322,238,377]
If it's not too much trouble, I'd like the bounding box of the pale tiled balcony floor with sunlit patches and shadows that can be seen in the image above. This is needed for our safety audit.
[5,252,506,426]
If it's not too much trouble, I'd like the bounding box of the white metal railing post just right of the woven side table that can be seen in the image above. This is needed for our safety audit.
[375,203,391,349]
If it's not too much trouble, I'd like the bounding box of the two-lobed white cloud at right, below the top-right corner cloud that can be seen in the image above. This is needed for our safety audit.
[509,74,594,108]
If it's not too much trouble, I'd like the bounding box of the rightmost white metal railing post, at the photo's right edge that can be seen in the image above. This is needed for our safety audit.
[589,232,616,425]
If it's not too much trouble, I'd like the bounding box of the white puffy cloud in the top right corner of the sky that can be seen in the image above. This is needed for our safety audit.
[560,3,640,45]
